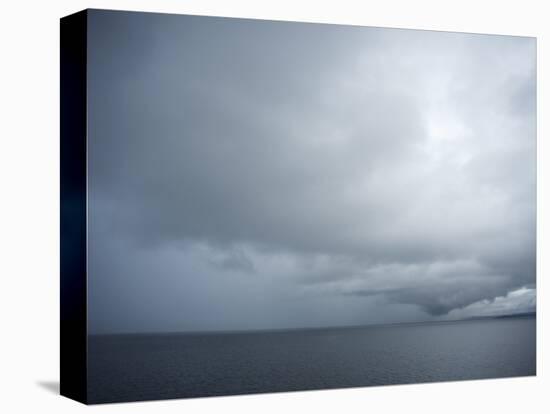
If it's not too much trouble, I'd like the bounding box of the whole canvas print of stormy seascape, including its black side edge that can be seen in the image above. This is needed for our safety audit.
[61,10,536,403]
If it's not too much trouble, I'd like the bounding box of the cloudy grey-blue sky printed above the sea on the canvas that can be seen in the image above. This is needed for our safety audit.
[88,11,536,333]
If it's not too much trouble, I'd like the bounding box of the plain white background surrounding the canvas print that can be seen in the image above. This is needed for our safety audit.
[0,0,550,414]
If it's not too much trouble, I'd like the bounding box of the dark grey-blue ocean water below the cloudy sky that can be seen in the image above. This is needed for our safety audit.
[88,317,536,403]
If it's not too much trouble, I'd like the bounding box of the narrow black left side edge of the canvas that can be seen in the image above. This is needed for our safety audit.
[59,10,88,403]
